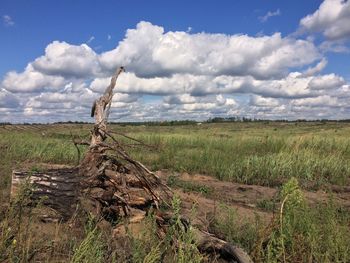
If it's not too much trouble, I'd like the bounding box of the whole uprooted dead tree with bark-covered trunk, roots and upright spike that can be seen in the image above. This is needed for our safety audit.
[11,67,252,263]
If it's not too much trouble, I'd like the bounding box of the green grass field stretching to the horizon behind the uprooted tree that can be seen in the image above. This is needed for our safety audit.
[0,123,350,193]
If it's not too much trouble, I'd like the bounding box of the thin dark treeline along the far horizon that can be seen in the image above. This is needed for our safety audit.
[0,117,350,126]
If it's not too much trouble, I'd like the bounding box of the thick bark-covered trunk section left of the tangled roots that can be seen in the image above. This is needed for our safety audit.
[11,168,81,221]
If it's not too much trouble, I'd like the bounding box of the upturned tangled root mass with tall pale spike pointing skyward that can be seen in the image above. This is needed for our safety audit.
[79,67,166,223]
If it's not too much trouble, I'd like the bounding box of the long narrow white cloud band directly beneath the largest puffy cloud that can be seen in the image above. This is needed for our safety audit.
[90,72,345,99]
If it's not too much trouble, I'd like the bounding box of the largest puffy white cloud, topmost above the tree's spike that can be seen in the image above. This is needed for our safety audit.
[99,22,321,79]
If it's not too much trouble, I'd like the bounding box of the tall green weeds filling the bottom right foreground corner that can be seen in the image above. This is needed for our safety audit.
[253,178,350,262]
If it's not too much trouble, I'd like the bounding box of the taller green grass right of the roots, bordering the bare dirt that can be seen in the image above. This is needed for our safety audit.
[130,134,350,186]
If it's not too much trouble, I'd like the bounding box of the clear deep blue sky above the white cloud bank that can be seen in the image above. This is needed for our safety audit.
[0,0,321,75]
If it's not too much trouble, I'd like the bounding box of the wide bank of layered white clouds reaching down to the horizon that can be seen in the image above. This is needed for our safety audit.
[0,22,350,122]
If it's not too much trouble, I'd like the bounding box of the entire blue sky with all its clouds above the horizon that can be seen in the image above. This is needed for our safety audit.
[0,0,350,123]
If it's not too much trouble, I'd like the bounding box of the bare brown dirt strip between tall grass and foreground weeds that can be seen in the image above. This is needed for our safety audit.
[157,171,350,230]
